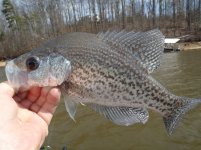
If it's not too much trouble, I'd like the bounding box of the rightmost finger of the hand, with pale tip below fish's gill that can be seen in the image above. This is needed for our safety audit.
[38,88,61,125]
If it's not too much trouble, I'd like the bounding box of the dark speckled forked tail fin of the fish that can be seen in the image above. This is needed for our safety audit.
[163,97,201,135]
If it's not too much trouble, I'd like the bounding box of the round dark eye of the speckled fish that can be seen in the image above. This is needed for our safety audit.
[26,57,40,71]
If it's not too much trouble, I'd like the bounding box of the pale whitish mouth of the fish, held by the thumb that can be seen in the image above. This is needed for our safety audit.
[5,60,29,92]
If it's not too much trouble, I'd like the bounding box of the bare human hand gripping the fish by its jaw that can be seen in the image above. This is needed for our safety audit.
[0,82,61,150]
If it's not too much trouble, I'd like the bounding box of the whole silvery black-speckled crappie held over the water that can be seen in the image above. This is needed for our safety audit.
[5,29,201,135]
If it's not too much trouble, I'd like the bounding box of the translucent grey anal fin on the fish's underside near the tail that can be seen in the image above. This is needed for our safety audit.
[87,104,149,126]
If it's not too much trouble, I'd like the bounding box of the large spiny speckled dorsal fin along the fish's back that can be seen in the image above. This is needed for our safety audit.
[98,29,165,73]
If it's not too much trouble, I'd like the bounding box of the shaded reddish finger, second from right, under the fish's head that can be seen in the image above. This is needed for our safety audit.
[30,87,52,113]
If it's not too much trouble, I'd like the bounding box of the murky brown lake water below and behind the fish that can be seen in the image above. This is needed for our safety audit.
[0,50,201,150]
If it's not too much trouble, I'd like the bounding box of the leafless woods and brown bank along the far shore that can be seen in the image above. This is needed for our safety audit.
[0,0,201,59]
